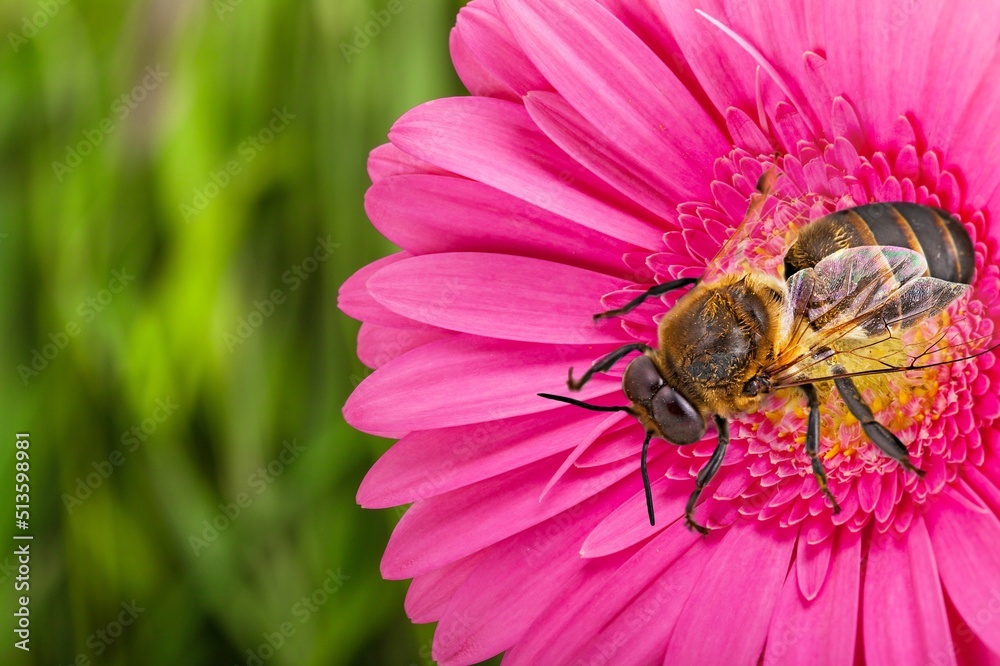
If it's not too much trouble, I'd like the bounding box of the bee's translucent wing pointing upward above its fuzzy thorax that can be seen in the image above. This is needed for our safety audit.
[702,167,809,282]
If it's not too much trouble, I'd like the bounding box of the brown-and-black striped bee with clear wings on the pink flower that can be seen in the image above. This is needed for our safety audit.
[539,170,995,534]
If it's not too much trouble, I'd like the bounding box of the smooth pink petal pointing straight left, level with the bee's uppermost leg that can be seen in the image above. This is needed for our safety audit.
[368,252,626,344]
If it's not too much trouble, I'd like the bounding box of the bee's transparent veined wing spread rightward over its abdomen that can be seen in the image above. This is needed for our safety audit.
[766,246,976,388]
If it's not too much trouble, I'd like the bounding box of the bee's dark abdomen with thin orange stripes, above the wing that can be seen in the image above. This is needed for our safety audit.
[785,202,976,284]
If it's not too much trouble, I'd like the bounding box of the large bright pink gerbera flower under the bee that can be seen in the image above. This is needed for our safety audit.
[340,0,1000,665]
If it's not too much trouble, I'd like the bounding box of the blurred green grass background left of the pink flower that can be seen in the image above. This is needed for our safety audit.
[0,0,498,665]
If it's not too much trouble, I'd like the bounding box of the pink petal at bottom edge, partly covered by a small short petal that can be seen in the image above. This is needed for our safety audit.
[764,529,861,666]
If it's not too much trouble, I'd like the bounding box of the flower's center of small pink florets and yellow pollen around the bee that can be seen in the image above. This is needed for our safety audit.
[612,120,993,538]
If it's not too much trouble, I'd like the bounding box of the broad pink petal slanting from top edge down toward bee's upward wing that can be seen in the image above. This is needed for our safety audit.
[497,0,729,203]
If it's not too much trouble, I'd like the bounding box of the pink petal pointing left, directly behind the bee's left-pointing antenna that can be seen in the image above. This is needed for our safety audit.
[344,335,624,437]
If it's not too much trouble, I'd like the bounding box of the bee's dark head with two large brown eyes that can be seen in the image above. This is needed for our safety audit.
[622,355,705,444]
